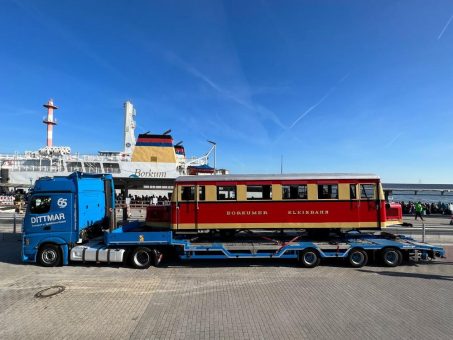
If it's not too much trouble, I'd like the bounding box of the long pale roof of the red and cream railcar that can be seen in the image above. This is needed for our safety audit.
[176,173,379,182]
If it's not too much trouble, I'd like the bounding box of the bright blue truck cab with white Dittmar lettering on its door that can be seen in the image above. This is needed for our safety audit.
[22,172,115,266]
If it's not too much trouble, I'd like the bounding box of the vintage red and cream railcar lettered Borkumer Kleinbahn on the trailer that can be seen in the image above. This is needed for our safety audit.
[147,174,402,231]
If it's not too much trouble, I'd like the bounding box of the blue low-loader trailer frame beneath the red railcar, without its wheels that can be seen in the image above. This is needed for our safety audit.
[100,222,445,266]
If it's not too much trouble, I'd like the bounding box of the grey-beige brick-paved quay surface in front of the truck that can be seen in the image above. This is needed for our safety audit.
[0,238,453,339]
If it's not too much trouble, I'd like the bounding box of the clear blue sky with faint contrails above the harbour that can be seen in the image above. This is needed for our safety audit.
[0,0,453,183]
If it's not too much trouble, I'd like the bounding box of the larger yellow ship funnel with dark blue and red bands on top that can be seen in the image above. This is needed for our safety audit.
[132,133,176,163]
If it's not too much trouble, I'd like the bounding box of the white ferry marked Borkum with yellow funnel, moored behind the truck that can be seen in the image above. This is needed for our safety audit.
[0,100,216,187]
